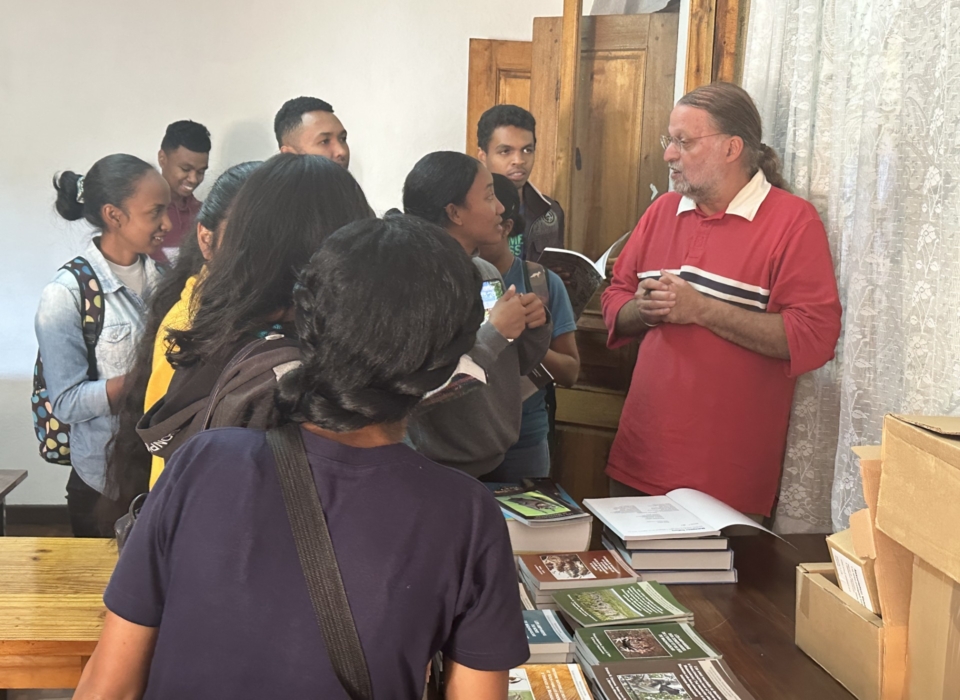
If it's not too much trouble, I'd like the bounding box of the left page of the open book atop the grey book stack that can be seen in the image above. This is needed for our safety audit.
[583,496,720,541]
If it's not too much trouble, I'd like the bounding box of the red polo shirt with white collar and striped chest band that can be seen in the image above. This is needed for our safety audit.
[603,173,841,515]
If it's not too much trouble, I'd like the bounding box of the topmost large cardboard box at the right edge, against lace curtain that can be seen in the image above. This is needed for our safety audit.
[876,415,960,581]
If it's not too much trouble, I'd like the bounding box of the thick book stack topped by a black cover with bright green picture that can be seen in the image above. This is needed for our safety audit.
[487,479,593,553]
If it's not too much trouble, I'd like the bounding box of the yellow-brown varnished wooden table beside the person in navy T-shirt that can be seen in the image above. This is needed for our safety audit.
[0,537,117,688]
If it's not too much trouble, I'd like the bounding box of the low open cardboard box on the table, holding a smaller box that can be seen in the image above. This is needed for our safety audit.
[796,564,886,700]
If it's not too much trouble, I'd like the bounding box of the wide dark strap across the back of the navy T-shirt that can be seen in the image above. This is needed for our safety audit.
[267,423,373,700]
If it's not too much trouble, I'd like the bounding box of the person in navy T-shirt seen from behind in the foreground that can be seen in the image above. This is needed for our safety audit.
[74,211,529,700]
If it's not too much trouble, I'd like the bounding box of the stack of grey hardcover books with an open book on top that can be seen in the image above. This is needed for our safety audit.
[584,489,769,584]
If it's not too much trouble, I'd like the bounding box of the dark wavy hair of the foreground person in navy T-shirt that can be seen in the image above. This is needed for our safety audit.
[277,214,483,432]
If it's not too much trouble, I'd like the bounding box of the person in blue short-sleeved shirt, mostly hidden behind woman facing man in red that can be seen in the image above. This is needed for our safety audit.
[480,173,580,482]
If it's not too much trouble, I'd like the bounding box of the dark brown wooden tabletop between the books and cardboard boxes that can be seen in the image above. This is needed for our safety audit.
[670,535,853,700]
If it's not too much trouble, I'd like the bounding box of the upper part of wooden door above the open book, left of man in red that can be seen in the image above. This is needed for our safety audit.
[530,12,679,259]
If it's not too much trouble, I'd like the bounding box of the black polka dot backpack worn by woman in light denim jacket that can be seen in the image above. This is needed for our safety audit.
[30,258,103,464]
